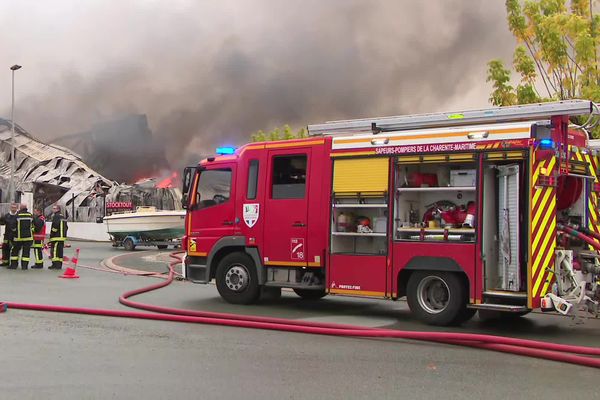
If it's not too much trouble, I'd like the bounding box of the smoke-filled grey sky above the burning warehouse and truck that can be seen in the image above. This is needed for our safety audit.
[0,0,515,167]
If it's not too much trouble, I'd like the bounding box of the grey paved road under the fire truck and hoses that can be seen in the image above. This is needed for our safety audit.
[0,243,600,400]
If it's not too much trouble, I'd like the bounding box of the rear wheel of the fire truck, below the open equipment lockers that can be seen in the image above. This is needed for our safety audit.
[406,271,472,326]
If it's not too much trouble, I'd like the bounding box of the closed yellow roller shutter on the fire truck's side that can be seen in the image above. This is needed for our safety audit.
[333,157,389,193]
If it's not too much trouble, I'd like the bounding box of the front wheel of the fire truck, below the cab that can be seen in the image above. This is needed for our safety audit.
[216,252,260,304]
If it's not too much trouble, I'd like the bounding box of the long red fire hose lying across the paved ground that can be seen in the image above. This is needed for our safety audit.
[0,253,600,368]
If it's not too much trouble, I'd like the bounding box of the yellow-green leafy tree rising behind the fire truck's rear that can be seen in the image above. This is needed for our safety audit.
[487,0,600,130]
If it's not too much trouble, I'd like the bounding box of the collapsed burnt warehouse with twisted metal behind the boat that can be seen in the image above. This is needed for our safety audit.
[0,118,181,221]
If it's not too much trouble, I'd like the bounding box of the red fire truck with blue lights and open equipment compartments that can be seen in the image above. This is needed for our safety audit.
[183,100,600,325]
